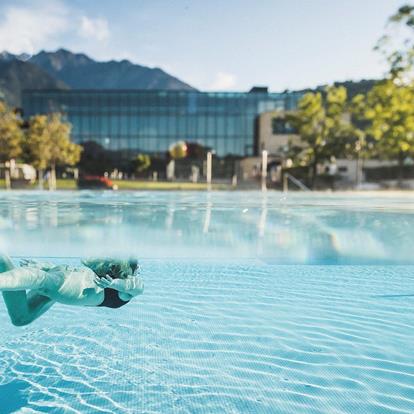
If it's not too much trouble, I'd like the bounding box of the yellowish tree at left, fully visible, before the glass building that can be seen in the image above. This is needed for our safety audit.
[26,114,81,189]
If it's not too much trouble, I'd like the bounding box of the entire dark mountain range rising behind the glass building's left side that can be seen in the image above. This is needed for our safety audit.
[0,49,195,106]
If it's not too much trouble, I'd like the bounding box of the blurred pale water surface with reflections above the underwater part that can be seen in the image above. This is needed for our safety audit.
[0,192,414,264]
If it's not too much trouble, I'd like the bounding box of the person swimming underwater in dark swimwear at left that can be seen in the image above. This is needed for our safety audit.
[0,255,144,326]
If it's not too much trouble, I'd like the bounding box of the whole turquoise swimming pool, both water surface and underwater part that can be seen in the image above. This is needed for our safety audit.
[0,191,414,413]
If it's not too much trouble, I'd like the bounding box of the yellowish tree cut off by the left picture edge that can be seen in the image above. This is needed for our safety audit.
[0,102,23,188]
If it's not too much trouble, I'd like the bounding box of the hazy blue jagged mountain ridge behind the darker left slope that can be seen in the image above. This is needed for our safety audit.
[29,49,194,90]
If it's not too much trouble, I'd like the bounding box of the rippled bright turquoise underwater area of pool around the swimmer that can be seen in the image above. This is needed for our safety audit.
[0,259,414,413]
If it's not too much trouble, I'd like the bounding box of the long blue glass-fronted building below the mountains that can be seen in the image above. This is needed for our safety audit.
[23,87,301,156]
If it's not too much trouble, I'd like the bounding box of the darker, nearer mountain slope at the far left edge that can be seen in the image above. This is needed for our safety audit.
[0,58,68,107]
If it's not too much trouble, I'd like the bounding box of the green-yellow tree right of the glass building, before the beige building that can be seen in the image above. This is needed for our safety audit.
[286,87,351,187]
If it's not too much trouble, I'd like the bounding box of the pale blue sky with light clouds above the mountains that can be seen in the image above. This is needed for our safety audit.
[0,0,405,91]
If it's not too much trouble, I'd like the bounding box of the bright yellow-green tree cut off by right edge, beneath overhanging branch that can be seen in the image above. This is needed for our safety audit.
[353,79,414,186]
